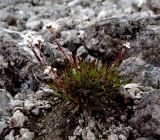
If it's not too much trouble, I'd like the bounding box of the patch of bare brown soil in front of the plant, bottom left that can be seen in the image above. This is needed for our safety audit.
[26,98,76,140]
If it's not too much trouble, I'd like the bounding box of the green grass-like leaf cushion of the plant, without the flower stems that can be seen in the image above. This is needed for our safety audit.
[50,59,126,112]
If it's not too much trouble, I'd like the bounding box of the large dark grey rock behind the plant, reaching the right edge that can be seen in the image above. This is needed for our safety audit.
[84,16,159,66]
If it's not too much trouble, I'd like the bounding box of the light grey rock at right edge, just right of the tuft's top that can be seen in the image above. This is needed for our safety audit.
[119,57,160,88]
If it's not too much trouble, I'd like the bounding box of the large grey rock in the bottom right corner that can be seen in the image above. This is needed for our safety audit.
[129,89,160,137]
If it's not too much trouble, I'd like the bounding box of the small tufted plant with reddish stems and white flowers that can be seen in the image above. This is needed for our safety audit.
[26,29,130,112]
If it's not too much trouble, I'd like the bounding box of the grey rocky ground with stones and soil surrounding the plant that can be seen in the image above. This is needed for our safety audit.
[0,0,160,140]
